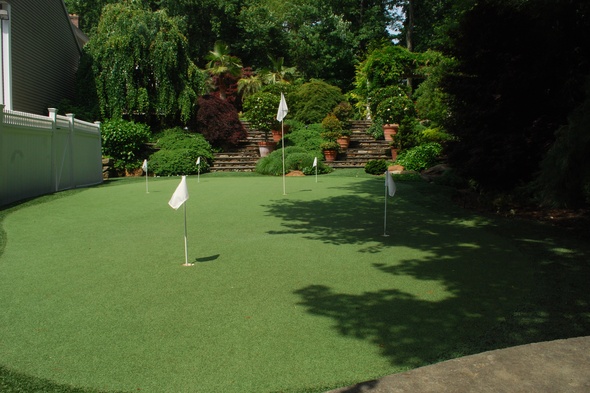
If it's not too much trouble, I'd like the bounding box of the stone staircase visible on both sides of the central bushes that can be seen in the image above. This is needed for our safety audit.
[211,120,391,172]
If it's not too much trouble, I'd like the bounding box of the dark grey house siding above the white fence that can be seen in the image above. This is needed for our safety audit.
[10,0,80,115]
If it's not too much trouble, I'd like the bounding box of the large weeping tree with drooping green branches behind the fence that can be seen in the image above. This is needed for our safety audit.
[85,2,205,125]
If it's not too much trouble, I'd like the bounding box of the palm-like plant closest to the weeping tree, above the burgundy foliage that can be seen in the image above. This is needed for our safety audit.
[206,41,242,100]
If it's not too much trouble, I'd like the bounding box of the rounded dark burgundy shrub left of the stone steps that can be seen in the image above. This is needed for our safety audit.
[197,95,247,147]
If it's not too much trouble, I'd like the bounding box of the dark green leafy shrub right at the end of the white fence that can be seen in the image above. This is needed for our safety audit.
[101,119,150,170]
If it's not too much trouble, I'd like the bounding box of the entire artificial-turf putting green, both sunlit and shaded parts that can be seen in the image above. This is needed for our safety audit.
[0,171,590,392]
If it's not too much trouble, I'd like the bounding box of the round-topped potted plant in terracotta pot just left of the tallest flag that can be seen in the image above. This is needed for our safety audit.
[244,92,280,157]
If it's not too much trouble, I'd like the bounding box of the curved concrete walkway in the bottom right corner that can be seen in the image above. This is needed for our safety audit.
[328,336,590,393]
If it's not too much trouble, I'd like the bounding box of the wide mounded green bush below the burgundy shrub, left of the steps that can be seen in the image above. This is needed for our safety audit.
[149,128,213,176]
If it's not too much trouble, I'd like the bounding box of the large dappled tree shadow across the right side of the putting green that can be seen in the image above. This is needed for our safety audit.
[268,181,590,369]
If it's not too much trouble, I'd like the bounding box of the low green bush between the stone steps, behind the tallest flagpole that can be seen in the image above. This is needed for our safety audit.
[256,146,332,176]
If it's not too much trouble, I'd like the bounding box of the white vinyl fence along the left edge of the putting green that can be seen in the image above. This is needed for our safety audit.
[0,105,102,206]
